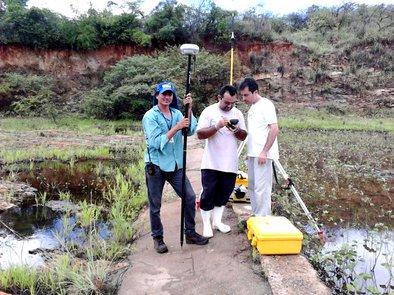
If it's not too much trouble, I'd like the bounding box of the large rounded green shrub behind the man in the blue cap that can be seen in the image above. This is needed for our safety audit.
[84,47,228,120]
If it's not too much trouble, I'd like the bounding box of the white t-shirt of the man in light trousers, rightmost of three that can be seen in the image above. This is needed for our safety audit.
[248,97,279,159]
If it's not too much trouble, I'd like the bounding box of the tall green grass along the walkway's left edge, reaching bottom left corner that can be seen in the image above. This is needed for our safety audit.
[0,160,147,295]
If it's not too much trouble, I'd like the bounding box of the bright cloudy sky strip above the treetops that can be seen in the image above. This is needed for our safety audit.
[27,0,394,17]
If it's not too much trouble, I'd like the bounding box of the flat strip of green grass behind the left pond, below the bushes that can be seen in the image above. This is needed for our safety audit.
[0,116,139,135]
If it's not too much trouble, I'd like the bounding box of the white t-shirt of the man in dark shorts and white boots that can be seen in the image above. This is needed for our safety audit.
[197,103,246,173]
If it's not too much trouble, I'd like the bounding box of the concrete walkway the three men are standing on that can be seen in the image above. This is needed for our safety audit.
[119,138,331,295]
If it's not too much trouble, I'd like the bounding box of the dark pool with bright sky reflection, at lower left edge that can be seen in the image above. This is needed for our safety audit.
[0,206,110,269]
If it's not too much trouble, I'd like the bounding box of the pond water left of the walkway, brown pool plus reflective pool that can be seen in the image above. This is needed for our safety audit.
[0,161,124,269]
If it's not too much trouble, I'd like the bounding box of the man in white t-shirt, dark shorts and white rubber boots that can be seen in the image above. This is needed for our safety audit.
[197,85,247,238]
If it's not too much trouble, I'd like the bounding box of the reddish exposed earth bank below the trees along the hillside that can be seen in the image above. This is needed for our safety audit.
[0,40,294,77]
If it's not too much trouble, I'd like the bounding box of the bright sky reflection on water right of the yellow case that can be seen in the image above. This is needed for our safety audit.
[323,228,394,291]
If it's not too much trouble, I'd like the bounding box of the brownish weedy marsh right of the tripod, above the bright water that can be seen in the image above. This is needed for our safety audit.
[279,129,394,225]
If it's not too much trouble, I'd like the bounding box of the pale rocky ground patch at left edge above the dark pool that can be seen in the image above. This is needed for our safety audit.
[0,180,37,212]
